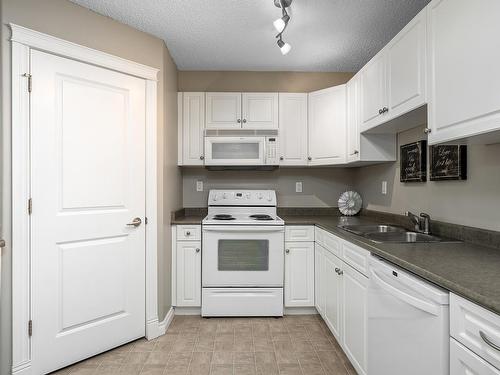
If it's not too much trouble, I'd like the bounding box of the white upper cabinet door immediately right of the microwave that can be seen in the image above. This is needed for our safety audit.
[279,93,307,165]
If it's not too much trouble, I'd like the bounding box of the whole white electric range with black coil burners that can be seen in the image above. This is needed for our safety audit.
[201,190,285,316]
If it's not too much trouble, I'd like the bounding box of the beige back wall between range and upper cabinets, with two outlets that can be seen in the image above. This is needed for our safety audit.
[182,168,355,207]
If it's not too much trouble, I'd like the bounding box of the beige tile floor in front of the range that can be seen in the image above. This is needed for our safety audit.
[54,315,356,375]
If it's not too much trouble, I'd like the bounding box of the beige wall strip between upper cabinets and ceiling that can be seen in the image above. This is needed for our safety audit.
[178,71,354,92]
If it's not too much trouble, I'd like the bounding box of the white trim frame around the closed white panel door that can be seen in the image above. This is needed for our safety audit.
[9,24,162,375]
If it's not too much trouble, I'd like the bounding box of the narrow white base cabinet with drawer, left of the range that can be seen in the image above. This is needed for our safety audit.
[172,225,201,307]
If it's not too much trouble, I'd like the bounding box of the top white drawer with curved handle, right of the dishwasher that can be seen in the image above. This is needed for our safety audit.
[450,294,500,369]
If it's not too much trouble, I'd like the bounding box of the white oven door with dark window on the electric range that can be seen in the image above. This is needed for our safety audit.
[202,225,285,287]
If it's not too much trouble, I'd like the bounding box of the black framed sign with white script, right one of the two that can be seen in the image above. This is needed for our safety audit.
[430,145,467,181]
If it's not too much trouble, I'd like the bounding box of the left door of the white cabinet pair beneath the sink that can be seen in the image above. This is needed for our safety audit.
[322,250,344,342]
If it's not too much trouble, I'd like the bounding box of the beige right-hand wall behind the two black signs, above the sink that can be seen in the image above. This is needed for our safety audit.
[355,126,500,231]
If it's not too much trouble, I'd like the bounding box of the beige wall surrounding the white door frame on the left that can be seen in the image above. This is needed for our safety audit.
[0,0,182,374]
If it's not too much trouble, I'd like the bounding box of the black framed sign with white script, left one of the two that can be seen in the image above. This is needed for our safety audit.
[399,140,427,182]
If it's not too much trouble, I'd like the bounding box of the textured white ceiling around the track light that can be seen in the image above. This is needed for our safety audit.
[71,0,429,72]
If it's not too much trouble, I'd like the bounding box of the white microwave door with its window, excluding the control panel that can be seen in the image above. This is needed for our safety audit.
[205,137,266,166]
